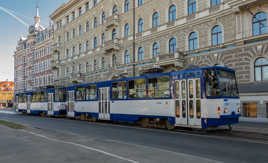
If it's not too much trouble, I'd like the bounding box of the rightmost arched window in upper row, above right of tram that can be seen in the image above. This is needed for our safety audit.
[252,12,267,36]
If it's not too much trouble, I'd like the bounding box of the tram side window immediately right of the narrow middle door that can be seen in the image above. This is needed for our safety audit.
[112,81,127,100]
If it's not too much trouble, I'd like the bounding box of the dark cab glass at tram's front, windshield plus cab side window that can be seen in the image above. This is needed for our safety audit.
[205,70,238,97]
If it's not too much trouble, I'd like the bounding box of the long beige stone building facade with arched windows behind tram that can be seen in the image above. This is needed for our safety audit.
[50,0,268,120]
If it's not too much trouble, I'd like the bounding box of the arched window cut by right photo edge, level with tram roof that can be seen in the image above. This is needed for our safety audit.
[254,58,268,81]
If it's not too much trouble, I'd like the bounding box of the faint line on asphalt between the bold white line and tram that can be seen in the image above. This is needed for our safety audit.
[105,139,223,163]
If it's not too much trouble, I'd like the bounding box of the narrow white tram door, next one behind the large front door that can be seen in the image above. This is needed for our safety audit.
[99,87,111,120]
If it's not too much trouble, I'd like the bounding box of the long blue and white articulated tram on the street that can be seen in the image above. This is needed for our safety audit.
[15,66,241,129]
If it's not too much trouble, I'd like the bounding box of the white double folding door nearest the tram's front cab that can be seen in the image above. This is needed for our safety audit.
[174,79,201,127]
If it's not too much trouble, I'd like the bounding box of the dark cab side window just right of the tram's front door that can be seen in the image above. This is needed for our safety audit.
[205,70,220,96]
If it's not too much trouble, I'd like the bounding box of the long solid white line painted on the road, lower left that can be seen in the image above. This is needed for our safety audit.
[23,130,139,163]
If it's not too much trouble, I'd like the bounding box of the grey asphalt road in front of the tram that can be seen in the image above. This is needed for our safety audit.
[0,113,268,163]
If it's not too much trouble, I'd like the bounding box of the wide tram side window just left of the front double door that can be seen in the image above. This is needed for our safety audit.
[148,76,170,98]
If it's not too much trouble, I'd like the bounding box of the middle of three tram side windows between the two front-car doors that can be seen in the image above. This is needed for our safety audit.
[128,79,146,99]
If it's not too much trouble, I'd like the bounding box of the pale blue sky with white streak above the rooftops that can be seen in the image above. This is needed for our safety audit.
[0,0,68,81]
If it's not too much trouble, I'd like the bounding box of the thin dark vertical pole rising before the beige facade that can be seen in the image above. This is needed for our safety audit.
[132,0,136,77]
